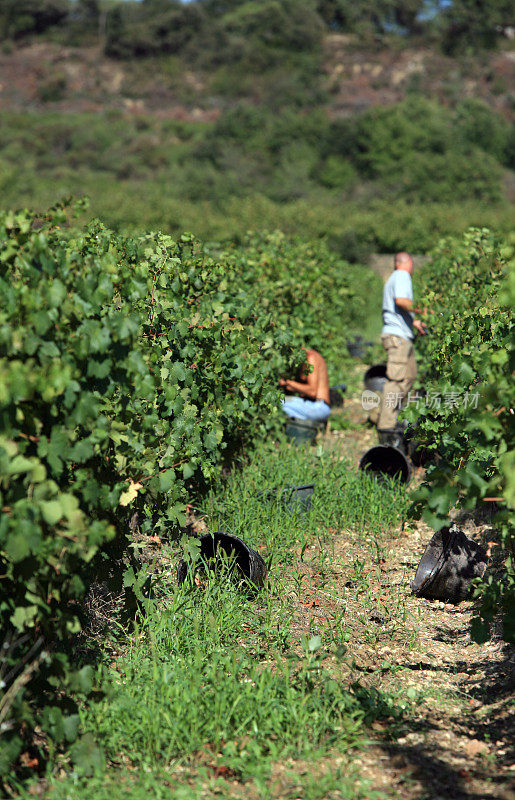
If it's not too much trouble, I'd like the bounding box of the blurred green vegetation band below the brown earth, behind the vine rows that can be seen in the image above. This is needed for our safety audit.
[0,97,515,253]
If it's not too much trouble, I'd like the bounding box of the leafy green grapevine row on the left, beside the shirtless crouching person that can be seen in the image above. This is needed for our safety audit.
[0,209,295,775]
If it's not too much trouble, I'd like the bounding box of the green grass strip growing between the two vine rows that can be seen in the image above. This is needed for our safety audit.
[32,444,407,800]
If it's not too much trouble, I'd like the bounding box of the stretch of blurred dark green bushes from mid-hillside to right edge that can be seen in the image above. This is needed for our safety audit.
[191,98,511,202]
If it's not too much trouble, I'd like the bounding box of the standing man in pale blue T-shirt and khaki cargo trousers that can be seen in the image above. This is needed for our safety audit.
[377,253,426,441]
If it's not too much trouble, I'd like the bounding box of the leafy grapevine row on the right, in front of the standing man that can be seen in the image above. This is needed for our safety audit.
[412,229,515,641]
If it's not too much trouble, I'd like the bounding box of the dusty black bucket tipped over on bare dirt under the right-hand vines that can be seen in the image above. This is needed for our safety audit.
[411,526,487,603]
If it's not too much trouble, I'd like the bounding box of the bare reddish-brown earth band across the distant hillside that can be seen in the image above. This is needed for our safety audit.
[0,34,515,122]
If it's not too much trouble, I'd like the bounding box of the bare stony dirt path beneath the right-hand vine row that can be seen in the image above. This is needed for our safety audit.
[298,378,515,800]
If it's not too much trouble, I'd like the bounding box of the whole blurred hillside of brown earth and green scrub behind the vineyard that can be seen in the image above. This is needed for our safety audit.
[0,13,515,250]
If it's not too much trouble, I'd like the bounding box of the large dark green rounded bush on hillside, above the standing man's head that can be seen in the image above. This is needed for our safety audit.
[329,97,510,202]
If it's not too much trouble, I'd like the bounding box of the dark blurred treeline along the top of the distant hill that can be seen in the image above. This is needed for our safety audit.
[0,0,513,55]
